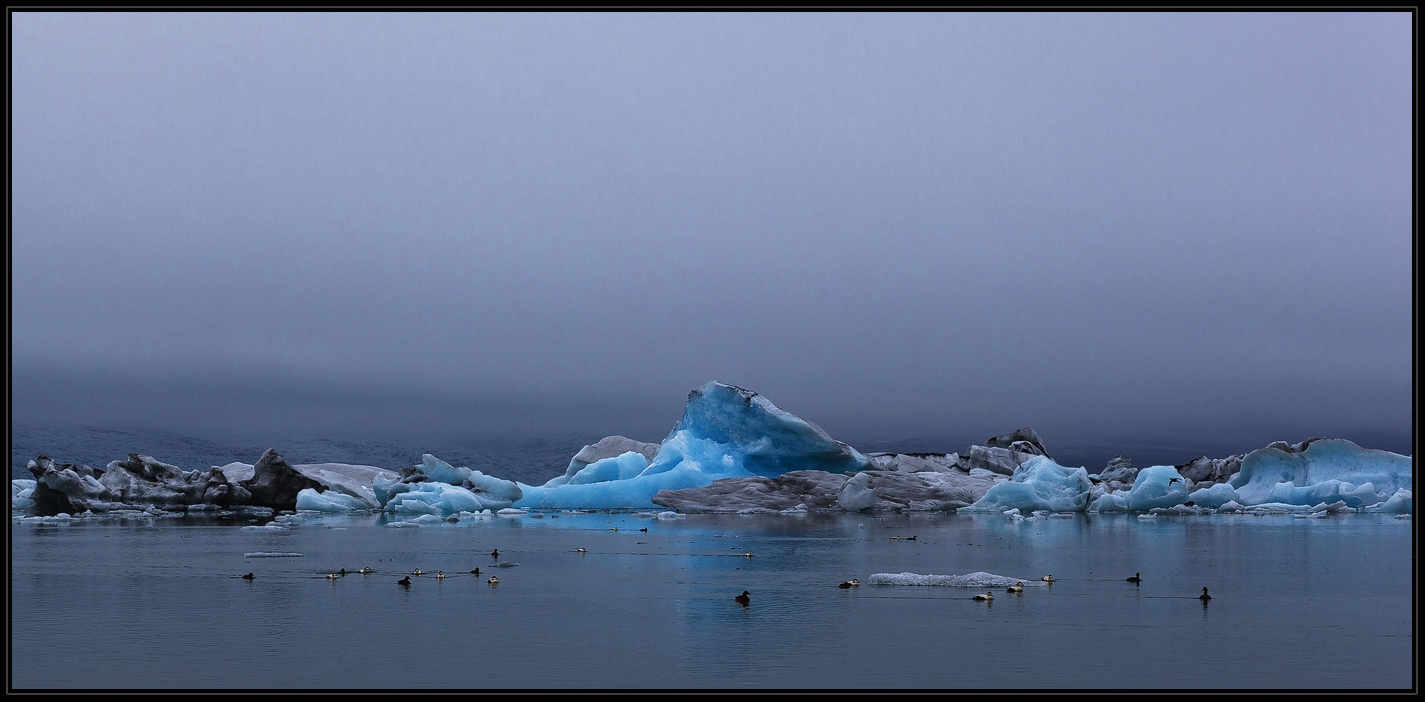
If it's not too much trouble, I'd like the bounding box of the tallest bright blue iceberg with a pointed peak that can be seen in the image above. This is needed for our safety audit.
[514,382,869,508]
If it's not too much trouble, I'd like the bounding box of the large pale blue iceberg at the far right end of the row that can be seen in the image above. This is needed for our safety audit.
[1228,439,1415,507]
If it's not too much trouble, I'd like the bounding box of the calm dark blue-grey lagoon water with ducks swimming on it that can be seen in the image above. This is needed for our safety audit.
[10,513,1415,689]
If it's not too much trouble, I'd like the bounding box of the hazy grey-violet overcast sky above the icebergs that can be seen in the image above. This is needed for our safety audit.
[10,11,1415,454]
